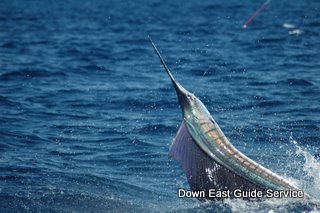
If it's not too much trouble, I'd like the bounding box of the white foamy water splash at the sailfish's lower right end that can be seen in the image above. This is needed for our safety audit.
[220,137,320,213]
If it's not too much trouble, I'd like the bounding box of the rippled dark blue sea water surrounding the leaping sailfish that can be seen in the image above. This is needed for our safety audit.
[0,0,320,212]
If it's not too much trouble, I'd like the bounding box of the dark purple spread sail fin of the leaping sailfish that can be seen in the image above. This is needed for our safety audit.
[169,121,264,200]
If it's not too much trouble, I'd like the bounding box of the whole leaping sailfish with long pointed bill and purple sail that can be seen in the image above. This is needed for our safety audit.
[149,37,300,200]
